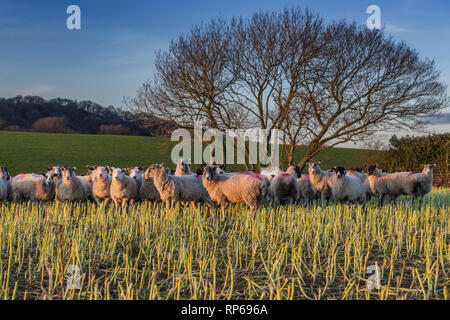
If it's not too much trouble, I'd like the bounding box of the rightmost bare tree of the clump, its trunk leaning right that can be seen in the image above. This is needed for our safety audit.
[299,21,448,167]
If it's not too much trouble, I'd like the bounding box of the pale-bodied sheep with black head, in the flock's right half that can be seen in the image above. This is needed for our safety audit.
[331,166,366,205]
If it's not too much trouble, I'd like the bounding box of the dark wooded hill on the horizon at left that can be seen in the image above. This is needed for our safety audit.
[0,96,175,136]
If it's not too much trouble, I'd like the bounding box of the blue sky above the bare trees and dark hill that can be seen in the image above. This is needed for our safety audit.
[0,0,450,124]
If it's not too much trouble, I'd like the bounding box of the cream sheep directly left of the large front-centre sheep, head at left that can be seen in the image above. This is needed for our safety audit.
[144,165,212,209]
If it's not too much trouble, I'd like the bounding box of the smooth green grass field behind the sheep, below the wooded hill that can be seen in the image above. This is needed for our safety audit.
[0,131,370,175]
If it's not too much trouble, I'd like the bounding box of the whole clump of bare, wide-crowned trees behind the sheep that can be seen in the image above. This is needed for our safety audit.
[126,8,448,168]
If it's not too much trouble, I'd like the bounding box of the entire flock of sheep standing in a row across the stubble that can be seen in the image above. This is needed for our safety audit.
[0,160,434,218]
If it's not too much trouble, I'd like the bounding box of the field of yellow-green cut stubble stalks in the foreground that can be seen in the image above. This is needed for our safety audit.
[0,189,450,300]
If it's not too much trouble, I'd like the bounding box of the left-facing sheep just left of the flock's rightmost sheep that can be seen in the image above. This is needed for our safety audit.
[368,165,421,206]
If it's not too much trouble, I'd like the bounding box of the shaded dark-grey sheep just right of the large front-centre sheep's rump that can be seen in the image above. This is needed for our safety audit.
[269,166,301,203]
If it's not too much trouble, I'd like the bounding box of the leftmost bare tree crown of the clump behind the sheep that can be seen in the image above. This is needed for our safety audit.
[127,19,247,130]
